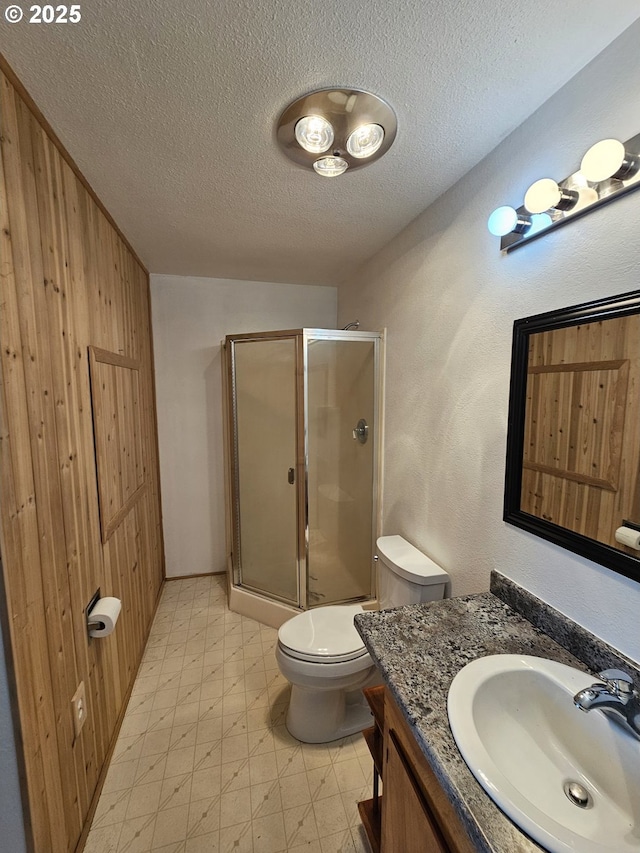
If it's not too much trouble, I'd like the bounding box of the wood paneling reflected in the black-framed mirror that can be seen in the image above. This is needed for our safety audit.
[521,314,640,553]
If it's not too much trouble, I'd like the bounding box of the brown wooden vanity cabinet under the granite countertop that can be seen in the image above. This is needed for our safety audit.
[360,688,474,853]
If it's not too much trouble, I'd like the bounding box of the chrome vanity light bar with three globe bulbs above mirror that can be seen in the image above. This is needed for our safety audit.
[487,134,640,252]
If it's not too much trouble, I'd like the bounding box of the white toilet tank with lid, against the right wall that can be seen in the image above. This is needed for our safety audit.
[376,535,449,610]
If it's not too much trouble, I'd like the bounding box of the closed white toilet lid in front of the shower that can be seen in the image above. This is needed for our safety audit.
[278,604,367,661]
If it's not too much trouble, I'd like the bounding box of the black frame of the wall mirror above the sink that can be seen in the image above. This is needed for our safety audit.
[503,290,640,583]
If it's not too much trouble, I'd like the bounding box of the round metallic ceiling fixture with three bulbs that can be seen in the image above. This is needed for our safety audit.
[277,89,397,178]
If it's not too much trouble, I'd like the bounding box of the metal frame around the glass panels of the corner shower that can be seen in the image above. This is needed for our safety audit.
[224,328,384,611]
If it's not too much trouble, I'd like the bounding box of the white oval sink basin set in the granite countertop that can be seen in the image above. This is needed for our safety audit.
[448,655,640,853]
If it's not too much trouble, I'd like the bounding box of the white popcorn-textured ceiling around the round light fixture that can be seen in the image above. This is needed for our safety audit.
[0,0,640,284]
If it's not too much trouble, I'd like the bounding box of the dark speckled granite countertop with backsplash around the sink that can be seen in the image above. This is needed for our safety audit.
[355,573,637,853]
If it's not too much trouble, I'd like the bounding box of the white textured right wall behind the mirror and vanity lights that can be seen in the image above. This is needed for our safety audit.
[338,22,640,661]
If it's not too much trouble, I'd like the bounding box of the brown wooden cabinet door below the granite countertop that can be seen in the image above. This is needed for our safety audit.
[382,729,449,853]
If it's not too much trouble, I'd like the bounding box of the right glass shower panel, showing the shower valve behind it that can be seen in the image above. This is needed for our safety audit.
[306,333,377,607]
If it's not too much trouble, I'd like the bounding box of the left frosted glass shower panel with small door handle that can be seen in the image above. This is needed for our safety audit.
[231,337,300,606]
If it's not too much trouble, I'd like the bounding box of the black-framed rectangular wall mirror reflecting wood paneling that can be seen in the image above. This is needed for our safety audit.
[504,291,640,582]
